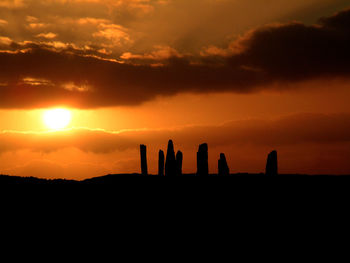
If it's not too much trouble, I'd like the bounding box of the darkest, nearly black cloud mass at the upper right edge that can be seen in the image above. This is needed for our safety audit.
[229,10,350,82]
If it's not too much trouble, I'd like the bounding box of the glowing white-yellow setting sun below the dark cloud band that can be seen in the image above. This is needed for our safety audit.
[43,109,72,130]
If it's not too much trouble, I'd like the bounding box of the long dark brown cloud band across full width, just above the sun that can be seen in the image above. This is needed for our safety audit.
[0,7,350,108]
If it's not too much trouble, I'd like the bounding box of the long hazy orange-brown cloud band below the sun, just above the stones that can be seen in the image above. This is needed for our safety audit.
[0,114,350,154]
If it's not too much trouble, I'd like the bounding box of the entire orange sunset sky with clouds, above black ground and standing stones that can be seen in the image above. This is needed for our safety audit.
[0,0,350,179]
